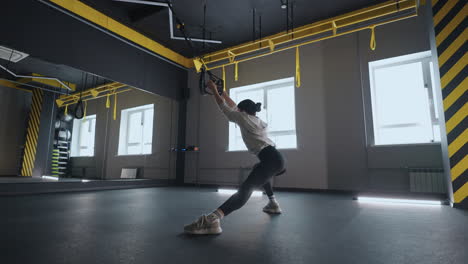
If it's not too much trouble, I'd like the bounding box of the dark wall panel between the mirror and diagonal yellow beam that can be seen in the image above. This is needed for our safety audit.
[0,0,187,99]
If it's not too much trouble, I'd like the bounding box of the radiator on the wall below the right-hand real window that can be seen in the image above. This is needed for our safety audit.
[409,168,447,193]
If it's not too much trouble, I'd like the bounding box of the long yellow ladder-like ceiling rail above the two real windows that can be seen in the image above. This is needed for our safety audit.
[196,0,425,69]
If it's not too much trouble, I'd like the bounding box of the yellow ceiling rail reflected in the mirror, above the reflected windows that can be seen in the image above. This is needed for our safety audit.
[55,82,132,107]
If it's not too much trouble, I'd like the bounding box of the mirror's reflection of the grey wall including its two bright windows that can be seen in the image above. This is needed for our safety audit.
[67,87,178,180]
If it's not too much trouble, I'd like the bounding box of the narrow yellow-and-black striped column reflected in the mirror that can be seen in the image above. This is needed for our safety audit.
[21,89,44,176]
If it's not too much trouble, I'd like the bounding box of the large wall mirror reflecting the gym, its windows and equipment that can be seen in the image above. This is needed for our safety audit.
[0,50,179,186]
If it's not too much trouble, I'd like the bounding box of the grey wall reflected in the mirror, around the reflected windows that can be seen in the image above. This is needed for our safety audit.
[72,89,178,179]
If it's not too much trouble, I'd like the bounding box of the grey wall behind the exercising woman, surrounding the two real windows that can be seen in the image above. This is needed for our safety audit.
[185,6,442,191]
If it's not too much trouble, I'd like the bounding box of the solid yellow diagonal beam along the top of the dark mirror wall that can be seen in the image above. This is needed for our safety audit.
[50,0,193,68]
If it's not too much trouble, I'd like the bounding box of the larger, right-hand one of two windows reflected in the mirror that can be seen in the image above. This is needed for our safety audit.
[118,104,154,155]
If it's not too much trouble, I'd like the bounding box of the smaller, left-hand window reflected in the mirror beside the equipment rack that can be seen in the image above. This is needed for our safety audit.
[71,115,96,157]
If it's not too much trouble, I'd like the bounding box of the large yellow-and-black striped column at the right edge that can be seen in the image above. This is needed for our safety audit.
[432,0,468,206]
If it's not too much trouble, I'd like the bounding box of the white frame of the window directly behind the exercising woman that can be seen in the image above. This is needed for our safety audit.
[227,77,298,152]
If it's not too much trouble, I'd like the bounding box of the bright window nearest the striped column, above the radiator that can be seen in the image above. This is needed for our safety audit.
[369,51,440,145]
